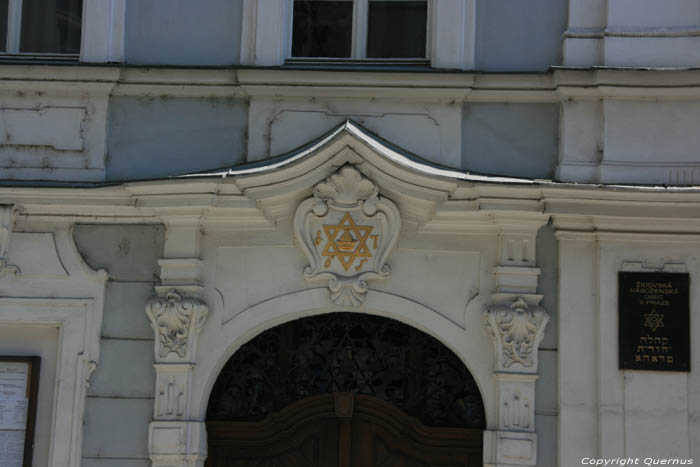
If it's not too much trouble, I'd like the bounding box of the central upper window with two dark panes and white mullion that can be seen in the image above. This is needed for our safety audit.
[291,0,428,59]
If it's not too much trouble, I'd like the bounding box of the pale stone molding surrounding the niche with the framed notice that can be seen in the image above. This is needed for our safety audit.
[0,229,108,467]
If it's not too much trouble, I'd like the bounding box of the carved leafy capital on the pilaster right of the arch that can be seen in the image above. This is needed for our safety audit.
[484,297,549,373]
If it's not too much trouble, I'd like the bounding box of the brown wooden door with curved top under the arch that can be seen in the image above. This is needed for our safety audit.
[205,393,483,467]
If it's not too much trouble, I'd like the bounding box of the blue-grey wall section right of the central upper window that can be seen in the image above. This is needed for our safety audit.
[476,0,569,71]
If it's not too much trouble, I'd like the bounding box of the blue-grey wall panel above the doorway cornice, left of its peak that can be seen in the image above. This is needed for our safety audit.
[106,96,248,181]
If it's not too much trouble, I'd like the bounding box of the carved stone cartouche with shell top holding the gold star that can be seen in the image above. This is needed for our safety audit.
[294,165,401,307]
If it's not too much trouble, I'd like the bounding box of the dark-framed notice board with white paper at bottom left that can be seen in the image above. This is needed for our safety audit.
[0,355,41,467]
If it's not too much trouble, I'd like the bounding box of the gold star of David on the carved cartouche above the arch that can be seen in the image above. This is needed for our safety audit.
[321,212,374,271]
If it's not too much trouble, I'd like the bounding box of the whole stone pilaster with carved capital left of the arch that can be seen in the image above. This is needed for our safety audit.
[146,220,209,467]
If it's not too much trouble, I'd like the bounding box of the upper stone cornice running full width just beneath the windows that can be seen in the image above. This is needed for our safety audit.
[0,64,700,102]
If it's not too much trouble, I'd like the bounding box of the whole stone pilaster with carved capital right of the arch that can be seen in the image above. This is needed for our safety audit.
[484,216,549,467]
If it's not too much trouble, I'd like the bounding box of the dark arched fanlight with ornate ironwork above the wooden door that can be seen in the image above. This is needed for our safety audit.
[207,313,484,428]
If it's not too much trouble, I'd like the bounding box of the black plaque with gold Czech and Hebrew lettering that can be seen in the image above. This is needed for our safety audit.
[619,272,690,371]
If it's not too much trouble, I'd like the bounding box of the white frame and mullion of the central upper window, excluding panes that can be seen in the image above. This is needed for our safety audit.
[285,0,435,65]
